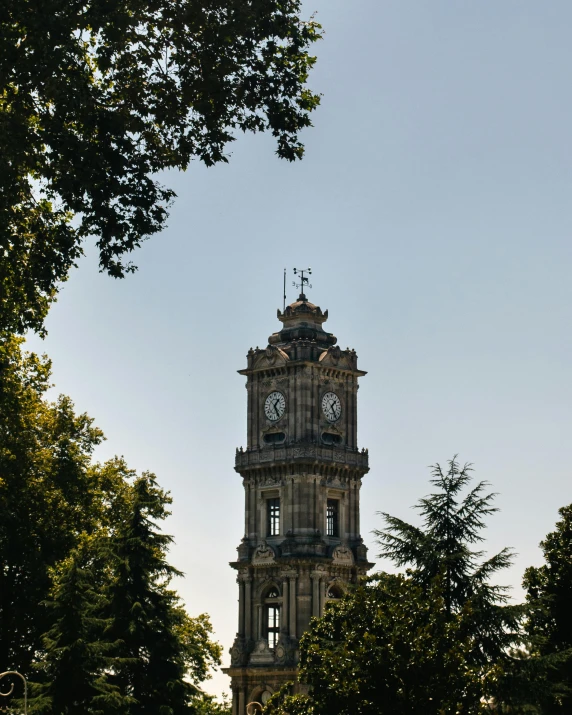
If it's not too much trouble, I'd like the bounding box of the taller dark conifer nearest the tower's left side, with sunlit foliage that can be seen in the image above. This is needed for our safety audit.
[107,474,220,715]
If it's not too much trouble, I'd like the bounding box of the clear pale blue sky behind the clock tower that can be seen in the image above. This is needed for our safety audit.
[25,0,572,692]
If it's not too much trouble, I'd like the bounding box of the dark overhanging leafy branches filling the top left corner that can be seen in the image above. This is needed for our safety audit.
[0,0,320,332]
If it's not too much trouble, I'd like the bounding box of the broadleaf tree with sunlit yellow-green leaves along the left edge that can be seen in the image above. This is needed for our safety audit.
[0,338,106,672]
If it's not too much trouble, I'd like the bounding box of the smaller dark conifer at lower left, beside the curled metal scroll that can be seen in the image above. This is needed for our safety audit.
[31,539,128,715]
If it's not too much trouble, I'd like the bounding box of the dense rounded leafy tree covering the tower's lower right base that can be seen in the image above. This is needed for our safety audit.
[265,574,494,715]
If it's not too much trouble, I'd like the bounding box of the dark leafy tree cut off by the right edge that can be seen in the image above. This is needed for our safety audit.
[523,504,572,715]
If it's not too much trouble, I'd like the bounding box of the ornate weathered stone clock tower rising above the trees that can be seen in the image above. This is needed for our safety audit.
[225,293,371,715]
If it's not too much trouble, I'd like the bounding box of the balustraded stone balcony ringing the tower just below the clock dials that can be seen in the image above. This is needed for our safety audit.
[234,442,369,474]
